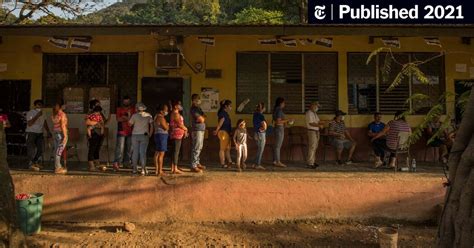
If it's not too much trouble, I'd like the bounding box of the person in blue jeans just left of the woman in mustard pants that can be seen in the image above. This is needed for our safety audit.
[190,94,206,173]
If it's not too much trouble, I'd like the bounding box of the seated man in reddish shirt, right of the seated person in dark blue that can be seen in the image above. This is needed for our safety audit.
[371,110,411,167]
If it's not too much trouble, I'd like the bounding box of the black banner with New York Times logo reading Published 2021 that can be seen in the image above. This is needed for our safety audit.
[308,0,474,24]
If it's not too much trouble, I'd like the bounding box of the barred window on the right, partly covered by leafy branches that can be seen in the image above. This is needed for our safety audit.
[347,53,445,114]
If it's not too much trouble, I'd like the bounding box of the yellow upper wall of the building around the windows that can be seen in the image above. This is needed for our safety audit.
[0,35,474,127]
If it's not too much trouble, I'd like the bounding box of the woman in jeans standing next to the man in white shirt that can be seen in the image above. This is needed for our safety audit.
[273,97,293,167]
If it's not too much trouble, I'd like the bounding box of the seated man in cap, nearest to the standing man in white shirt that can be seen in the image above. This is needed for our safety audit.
[328,110,356,165]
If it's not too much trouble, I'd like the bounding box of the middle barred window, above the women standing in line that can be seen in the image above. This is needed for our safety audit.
[236,52,338,114]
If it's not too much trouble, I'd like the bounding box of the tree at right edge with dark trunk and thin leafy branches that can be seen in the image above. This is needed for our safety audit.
[367,47,474,248]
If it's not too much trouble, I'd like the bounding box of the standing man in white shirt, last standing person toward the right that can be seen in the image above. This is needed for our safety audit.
[305,102,320,169]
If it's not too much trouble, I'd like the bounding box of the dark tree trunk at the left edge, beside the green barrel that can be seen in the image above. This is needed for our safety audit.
[0,123,26,247]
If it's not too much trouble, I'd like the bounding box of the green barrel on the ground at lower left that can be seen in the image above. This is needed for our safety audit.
[16,193,43,235]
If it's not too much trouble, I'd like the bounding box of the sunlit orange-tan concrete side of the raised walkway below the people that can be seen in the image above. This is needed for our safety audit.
[13,172,444,222]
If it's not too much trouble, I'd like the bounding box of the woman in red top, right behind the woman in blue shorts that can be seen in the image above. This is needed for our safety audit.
[170,101,188,174]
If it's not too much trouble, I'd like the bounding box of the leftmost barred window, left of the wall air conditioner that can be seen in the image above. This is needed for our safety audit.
[43,53,138,111]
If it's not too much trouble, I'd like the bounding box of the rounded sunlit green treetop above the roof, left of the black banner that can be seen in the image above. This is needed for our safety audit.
[232,7,284,24]
